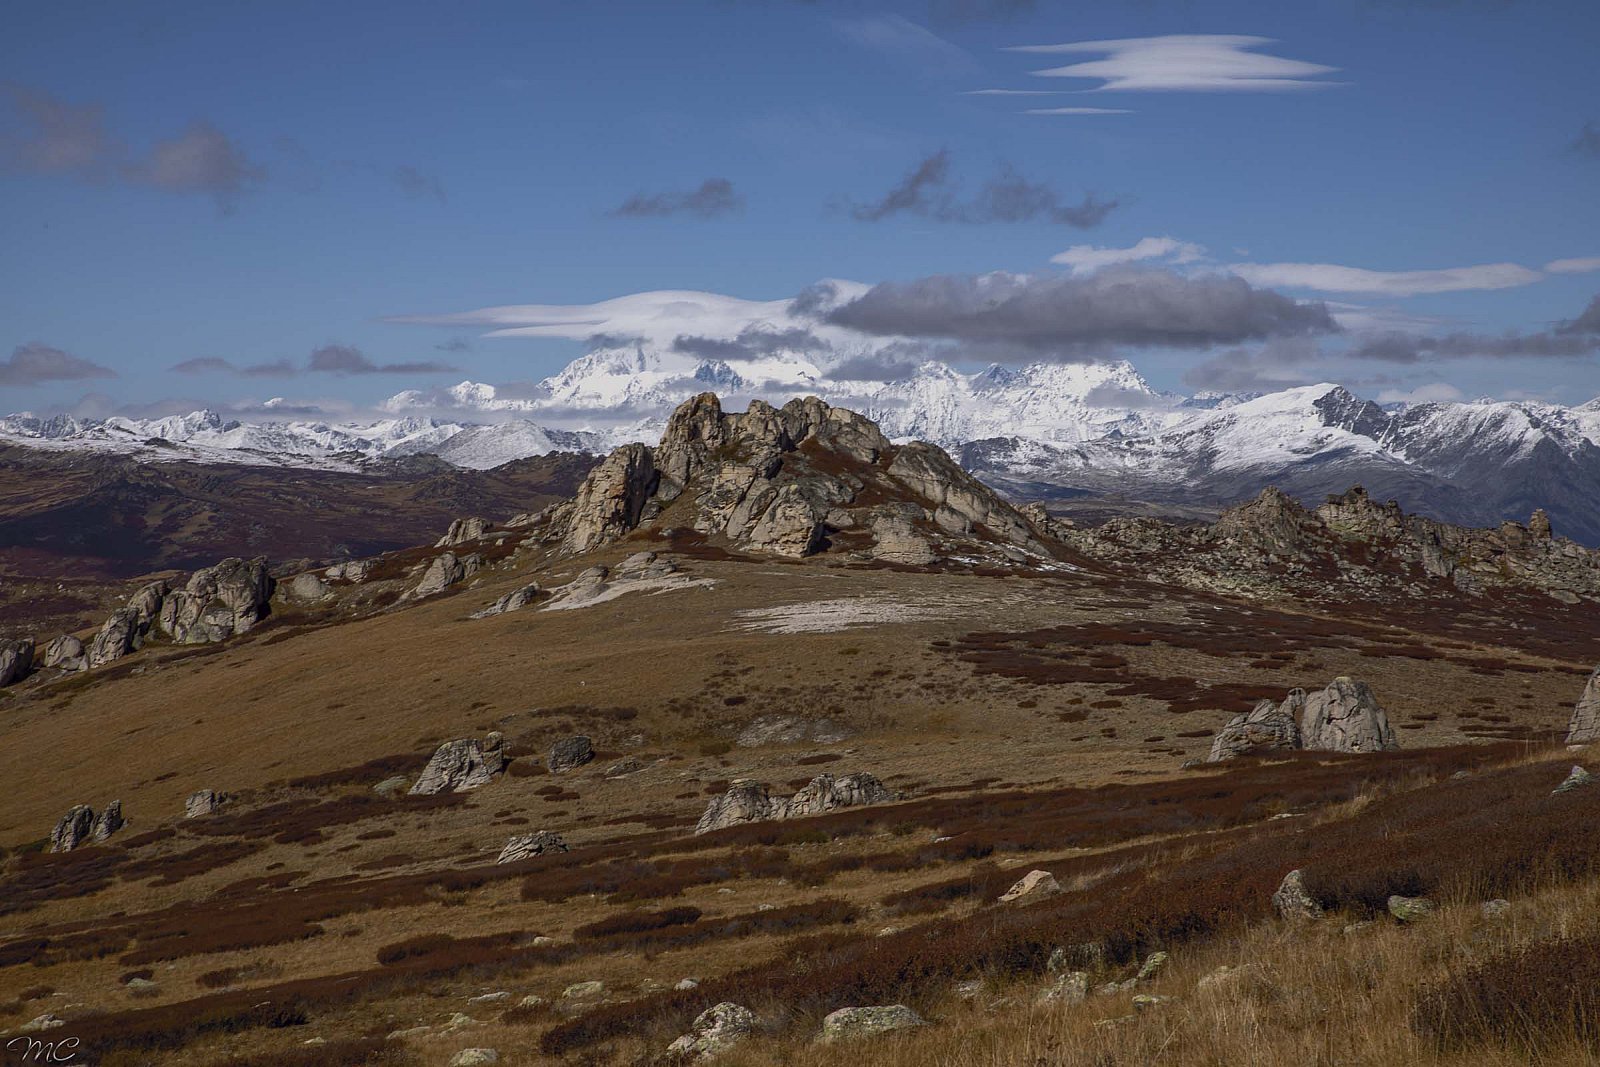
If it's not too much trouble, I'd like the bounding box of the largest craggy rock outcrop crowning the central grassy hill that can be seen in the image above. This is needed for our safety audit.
[552,394,1050,565]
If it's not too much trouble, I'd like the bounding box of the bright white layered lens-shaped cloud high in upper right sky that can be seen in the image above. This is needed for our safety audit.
[1010,34,1338,93]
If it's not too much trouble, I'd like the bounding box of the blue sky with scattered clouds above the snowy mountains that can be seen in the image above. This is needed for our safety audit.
[0,0,1600,411]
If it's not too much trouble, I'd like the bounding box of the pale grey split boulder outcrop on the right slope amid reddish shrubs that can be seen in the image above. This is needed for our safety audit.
[1206,677,1400,763]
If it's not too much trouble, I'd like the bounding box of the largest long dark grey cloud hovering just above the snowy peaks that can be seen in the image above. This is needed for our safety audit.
[826,269,1339,358]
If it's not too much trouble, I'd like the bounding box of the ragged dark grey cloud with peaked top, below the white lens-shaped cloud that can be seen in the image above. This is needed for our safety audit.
[850,149,1117,229]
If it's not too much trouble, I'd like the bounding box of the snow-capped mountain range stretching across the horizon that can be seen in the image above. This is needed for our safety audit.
[9,341,1600,542]
